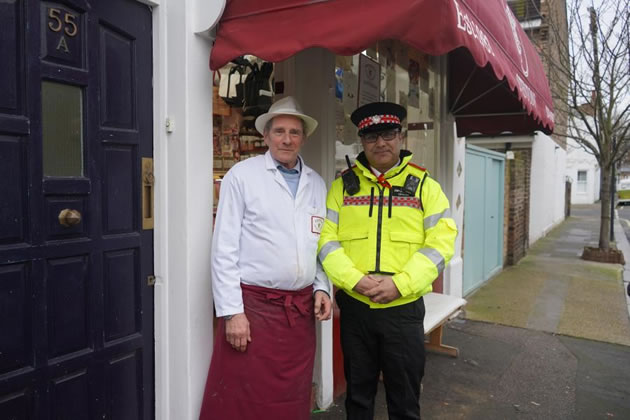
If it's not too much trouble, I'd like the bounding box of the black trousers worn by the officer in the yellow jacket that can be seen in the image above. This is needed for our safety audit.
[336,290,425,420]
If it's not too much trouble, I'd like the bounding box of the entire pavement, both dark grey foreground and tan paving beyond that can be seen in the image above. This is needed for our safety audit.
[311,204,630,420]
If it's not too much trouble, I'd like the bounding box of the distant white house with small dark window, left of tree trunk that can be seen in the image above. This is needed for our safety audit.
[566,139,600,204]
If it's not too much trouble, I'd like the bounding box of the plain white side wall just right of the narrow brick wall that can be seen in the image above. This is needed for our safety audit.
[529,132,567,246]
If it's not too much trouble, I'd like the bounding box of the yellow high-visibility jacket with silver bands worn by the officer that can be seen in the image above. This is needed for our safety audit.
[318,150,457,308]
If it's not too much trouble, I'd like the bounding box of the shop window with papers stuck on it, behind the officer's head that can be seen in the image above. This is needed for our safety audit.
[335,40,440,174]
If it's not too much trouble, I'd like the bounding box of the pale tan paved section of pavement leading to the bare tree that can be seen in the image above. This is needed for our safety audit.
[466,204,630,346]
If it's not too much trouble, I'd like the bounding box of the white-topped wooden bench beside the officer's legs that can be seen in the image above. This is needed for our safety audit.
[424,292,468,357]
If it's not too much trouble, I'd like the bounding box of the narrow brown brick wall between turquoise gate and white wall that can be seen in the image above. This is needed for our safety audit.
[504,149,532,265]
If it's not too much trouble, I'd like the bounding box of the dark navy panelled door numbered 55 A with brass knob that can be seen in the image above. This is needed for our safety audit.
[0,0,154,419]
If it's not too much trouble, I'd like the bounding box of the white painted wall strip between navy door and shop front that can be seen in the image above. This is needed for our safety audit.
[152,0,225,420]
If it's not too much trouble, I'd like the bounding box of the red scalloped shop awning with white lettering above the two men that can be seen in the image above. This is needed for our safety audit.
[210,0,553,136]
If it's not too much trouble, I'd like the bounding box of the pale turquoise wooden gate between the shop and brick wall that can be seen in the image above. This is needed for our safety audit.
[463,145,505,294]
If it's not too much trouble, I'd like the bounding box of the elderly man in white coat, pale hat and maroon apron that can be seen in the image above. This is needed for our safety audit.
[200,96,331,420]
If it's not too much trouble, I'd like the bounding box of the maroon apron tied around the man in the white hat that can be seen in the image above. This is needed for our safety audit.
[199,284,315,420]
